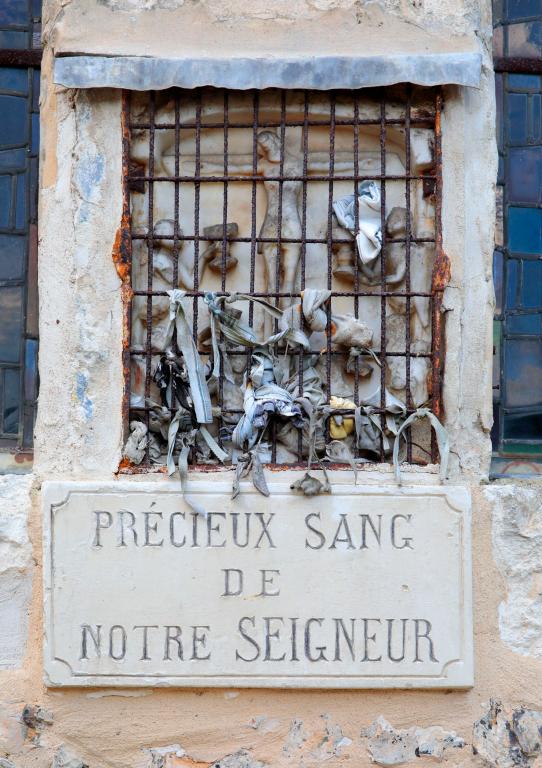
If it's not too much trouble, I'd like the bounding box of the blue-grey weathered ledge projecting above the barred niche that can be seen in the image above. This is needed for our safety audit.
[54,52,482,91]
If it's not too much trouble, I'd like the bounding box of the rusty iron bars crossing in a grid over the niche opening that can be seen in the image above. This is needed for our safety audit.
[126,89,449,471]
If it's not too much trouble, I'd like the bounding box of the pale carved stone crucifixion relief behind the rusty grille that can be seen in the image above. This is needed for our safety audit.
[132,88,442,464]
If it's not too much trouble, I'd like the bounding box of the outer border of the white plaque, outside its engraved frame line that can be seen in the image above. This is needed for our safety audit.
[42,480,474,689]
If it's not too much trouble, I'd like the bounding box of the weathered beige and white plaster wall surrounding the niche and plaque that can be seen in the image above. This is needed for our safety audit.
[0,0,542,768]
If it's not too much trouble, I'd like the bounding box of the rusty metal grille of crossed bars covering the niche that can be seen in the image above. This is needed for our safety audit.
[122,87,448,471]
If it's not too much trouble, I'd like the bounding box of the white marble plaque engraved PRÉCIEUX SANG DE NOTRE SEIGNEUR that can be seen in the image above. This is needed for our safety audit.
[44,480,473,688]
